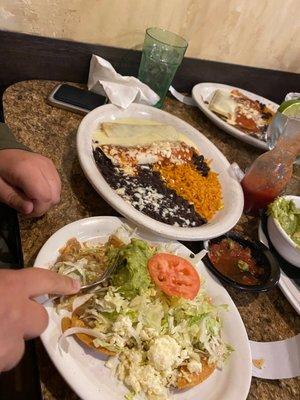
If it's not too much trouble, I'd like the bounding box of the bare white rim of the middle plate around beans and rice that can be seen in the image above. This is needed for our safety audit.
[77,104,244,240]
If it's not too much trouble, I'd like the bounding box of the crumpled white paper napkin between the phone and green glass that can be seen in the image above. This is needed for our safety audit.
[88,54,159,108]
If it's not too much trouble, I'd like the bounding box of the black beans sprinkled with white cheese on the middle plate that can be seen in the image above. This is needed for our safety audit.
[94,148,207,227]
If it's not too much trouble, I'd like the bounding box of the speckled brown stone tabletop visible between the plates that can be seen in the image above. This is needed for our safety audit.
[3,81,300,400]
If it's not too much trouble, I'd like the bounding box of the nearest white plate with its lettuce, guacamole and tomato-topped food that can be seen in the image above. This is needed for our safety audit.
[35,217,252,400]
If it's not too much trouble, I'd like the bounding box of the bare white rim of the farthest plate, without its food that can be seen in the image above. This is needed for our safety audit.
[192,82,279,150]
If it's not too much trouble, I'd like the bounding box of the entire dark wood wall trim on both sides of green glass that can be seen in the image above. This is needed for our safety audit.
[0,31,300,102]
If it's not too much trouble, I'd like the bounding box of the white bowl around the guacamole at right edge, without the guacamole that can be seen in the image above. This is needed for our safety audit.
[267,196,300,268]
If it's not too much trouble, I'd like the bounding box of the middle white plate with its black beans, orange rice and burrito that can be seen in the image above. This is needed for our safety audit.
[77,104,243,240]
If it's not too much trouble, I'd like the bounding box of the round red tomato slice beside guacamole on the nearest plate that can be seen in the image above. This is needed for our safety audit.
[148,253,200,300]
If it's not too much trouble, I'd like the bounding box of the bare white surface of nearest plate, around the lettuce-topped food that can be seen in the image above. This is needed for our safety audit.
[34,217,252,400]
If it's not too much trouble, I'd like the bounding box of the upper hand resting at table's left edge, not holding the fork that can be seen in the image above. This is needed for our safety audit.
[0,149,61,217]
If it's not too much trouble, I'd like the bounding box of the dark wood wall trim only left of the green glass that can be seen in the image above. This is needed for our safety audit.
[0,31,141,90]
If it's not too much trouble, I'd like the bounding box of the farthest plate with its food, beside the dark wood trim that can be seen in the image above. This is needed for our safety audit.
[192,82,278,150]
